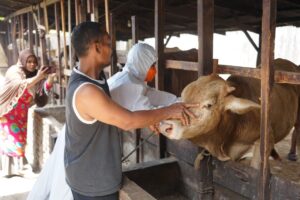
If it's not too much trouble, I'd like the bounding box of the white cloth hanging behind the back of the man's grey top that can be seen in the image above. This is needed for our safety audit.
[27,125,73,200]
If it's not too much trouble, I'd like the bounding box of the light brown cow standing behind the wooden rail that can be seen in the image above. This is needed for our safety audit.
[159,59,299,168]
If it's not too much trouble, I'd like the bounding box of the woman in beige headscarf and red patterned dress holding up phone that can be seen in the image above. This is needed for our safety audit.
[0,49,55,175]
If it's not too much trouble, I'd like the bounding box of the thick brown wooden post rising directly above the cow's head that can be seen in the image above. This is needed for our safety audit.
[197,0,214,76]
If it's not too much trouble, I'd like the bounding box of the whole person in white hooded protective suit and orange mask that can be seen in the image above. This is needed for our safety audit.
[27,43,177,200]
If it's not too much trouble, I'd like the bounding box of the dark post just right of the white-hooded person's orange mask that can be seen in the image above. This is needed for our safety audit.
[154,0,166,158]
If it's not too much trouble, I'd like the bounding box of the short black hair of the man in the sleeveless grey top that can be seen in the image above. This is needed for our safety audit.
[71,22,108,58]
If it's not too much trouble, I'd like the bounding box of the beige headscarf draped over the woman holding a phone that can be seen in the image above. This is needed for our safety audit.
[0,49,36,116]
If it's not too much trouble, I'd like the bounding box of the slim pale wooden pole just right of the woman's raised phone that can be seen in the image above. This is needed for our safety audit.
[54,3,63,104]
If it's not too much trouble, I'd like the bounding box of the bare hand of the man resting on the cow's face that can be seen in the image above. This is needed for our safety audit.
[169,103,199,126]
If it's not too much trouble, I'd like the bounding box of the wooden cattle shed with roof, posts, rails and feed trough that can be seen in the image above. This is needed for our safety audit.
[0,0,300,200]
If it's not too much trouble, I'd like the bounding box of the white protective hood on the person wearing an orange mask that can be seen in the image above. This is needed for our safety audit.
[123,43,157,81]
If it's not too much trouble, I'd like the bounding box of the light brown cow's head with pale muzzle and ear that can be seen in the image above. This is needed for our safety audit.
[160,75,260,139]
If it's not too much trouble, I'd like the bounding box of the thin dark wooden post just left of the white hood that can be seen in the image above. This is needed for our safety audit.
[109,13,119,75]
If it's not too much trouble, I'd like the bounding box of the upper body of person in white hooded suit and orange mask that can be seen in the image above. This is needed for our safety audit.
[107,43,177,111]
